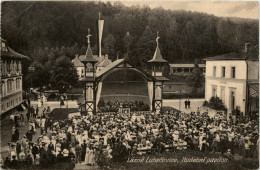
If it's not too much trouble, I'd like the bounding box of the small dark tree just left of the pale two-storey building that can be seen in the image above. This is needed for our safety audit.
[186,60,203,93]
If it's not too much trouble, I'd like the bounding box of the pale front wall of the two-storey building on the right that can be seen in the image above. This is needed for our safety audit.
[205,60,247,113]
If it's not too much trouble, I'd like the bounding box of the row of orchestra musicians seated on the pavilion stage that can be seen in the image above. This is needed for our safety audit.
[98,98,150,112]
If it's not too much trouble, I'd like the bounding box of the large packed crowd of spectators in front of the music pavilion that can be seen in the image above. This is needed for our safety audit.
[1,102,259,168]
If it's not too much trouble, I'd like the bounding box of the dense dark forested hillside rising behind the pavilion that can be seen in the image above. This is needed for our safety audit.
[1,1,259,74]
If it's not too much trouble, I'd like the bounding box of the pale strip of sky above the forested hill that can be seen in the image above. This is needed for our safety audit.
[117,0,259,19]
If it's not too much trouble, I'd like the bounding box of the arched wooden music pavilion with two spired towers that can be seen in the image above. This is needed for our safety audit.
[78,31,168,114]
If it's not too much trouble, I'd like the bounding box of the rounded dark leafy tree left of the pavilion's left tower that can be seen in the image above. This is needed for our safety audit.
[50,56,78,89]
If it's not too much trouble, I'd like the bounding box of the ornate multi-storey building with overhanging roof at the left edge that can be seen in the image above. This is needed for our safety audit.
[1,39,28,114]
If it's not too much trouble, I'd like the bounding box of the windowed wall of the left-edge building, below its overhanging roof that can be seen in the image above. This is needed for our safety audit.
[0,58,23,114]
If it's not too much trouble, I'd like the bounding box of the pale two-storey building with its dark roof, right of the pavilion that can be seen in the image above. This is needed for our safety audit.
[205,44,259,115]
